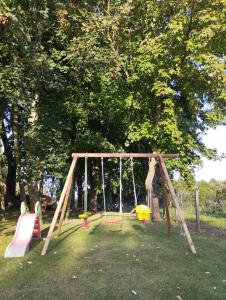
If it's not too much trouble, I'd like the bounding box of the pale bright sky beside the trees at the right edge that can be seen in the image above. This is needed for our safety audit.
[195,126,226,181]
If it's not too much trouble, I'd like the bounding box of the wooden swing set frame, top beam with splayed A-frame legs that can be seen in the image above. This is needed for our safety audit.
[41,153,196,255]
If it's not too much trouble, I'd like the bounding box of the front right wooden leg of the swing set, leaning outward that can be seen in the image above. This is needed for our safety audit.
[159,155,196,254]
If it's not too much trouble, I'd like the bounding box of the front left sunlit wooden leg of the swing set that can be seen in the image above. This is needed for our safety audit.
[41,156,77,255]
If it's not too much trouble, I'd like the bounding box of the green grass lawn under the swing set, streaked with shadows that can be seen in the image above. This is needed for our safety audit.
[0,215,226,300]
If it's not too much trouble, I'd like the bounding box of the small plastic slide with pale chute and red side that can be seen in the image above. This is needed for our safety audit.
[4,203,41,257]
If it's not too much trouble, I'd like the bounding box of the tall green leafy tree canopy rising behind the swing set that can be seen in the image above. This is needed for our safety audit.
[0,0,226,211]
